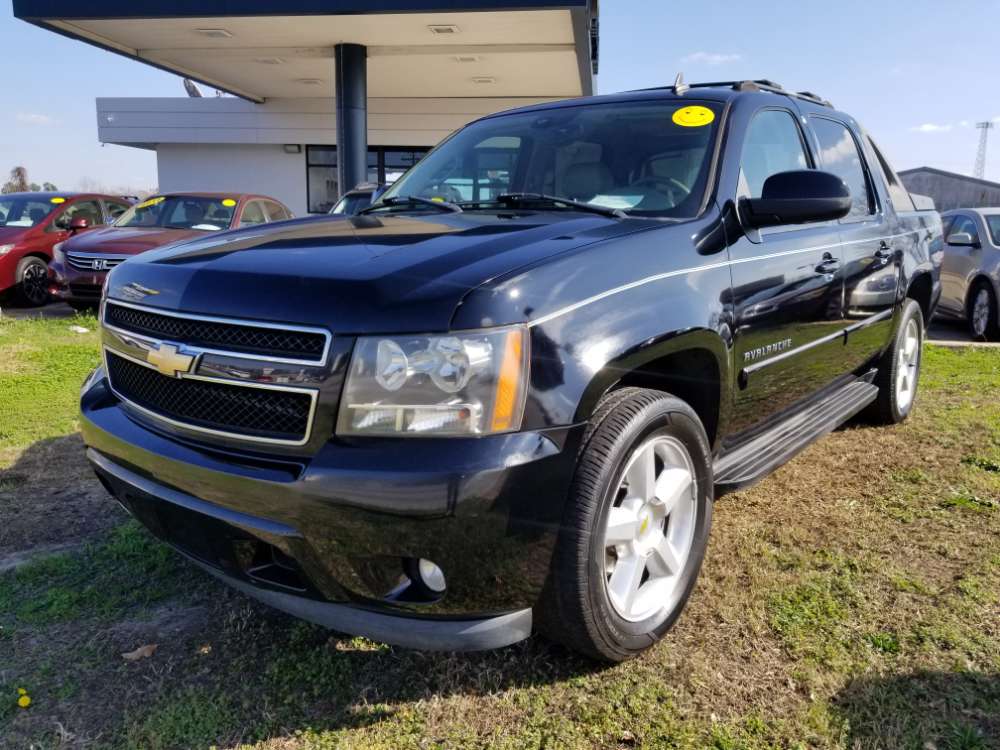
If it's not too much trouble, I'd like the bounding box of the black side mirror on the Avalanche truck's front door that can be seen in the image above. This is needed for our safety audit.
[741,169,851,227]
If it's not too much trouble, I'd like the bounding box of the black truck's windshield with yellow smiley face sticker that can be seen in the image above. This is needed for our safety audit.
[374,100,721,218]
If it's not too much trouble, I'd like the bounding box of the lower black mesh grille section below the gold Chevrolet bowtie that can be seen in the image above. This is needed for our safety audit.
[107,351,312,442]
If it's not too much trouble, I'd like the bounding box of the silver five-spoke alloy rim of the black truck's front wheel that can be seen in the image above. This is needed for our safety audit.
[601,436,697,622]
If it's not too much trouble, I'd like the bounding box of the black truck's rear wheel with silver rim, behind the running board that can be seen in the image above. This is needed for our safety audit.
[868,298,924,424]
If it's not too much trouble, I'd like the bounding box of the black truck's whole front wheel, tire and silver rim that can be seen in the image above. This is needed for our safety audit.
[538,388,713,662]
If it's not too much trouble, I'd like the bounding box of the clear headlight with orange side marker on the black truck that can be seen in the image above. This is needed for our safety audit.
[337,326,528,436]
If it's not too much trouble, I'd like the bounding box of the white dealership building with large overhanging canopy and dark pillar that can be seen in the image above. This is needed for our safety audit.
[14,0,598,215]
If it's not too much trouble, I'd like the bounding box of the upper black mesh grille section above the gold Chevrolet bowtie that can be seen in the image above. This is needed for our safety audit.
[104,302,327,362]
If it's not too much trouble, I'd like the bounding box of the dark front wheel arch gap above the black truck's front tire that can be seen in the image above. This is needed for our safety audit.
[577,329,730,446]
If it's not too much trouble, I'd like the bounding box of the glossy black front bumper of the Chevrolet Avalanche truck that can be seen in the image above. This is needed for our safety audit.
[81,380,583,650]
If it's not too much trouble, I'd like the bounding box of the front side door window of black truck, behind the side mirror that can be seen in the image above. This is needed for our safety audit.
[740,109,809,198]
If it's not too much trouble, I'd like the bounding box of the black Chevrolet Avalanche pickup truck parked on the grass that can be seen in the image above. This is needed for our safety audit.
[81,82,941,661]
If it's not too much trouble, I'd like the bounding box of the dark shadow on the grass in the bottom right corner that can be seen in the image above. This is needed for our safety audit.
[834,671,1000,750]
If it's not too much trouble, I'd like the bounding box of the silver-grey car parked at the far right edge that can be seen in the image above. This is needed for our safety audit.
[939,208,1000,341]
